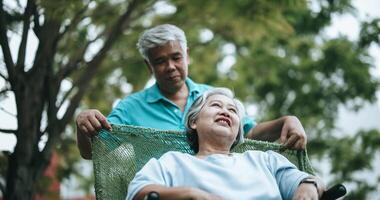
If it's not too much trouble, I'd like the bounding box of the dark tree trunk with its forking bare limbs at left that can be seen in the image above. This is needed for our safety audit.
[0,0,143,200]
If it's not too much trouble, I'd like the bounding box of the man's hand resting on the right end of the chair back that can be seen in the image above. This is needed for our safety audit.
[280,116,307,149]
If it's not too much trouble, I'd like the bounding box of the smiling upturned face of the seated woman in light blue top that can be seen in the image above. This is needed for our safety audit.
[191,94,240,144]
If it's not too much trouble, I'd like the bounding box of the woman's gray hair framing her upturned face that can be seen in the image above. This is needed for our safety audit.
[185,87,245,153]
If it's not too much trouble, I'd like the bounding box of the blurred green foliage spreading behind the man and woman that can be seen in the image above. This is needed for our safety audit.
[4,0,380,199]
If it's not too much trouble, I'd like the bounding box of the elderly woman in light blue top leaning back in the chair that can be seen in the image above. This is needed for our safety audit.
[127,88,324,199]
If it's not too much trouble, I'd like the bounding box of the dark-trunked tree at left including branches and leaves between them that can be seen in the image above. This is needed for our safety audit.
[0,0,156,199]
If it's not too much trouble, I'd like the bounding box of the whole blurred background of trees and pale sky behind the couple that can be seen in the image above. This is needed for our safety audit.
[0,0,380,199]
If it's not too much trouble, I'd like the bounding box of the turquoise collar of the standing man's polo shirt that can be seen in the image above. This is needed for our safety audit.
[146,78,200,103]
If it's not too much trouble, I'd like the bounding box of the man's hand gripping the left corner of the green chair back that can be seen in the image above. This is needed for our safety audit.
[76,109,111,137]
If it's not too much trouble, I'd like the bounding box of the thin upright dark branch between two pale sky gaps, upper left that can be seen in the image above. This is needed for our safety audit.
[16,0,36,72]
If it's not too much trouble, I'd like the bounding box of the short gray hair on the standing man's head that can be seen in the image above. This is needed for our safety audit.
[137,24,187,61]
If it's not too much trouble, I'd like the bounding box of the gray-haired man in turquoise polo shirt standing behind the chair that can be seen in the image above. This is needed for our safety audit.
[76,24,306,159]
